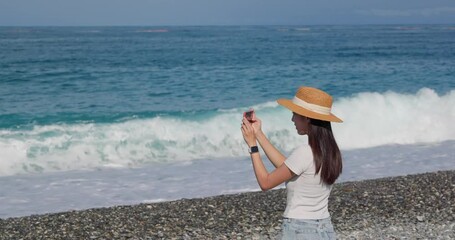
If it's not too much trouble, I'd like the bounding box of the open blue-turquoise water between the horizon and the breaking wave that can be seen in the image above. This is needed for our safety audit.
[0,25,455,125]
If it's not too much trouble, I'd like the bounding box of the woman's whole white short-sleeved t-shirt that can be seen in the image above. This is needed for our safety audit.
[284,145,332,219]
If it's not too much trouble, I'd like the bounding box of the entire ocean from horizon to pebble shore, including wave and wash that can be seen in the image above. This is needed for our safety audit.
[0,25,455,218]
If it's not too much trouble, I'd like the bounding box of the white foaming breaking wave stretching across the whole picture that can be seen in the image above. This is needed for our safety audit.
[0,88,455,176]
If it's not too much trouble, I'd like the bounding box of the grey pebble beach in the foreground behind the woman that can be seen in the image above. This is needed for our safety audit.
[0,171,455,239]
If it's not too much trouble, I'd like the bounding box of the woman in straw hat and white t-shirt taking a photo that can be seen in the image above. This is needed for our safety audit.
[241,87,342,239]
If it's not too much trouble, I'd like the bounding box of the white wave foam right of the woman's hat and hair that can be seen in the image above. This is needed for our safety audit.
[334,88,455,149]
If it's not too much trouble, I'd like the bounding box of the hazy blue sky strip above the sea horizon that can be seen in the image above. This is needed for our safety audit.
[0,0,455,26]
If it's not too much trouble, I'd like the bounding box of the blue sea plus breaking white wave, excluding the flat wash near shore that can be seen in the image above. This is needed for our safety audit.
[0,25,455,175]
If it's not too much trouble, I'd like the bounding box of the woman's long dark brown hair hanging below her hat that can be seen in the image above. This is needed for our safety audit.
[308,118,343,185]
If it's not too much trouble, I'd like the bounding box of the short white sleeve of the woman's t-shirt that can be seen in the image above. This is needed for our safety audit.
[284,145,313,175]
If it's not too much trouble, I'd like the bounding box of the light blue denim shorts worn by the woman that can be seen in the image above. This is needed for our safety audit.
[281,217,336,240]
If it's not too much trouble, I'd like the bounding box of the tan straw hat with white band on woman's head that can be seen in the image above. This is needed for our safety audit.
[277,87,343,122]
